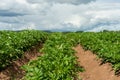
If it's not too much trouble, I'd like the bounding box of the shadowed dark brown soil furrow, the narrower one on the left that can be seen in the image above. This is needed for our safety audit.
[0,44,42,80]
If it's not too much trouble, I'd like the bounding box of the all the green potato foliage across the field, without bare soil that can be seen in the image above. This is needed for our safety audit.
[0,30,120,80]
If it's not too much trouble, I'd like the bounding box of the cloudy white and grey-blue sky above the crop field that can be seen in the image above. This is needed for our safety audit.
[0,0,120,31]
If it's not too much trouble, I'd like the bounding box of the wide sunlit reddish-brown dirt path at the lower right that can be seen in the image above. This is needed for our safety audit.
[75,45,120,80]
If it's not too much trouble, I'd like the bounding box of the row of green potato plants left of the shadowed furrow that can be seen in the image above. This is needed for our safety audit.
[0,30,47,70]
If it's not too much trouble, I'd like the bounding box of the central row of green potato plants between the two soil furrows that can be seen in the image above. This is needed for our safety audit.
[22,33,84,80]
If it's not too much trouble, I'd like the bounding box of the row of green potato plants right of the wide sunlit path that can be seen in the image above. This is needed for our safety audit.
[67,31,120,74]
